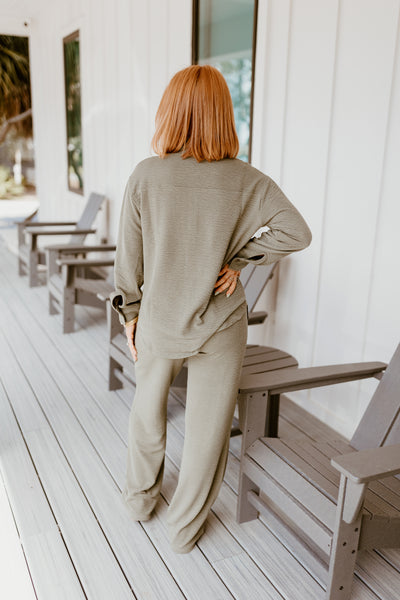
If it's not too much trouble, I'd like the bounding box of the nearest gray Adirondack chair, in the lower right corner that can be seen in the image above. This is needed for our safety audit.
[237,345,400,600]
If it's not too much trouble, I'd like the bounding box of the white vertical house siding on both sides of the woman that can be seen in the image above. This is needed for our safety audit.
[0,0,400,435]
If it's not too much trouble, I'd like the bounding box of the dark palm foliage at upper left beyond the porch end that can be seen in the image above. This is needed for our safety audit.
[0,35,32,137]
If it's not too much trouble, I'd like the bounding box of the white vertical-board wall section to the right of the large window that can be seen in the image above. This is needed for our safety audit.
[253,0,400,435]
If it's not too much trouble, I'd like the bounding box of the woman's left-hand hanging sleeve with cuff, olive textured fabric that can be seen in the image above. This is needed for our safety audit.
[110,180,143,324]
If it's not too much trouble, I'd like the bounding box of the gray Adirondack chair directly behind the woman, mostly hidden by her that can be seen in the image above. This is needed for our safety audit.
[104,263,278,392]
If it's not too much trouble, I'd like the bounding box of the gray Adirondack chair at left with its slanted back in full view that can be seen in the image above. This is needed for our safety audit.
[18,192,105,287]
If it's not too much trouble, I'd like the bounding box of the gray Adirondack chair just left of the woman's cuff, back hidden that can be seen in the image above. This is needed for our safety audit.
[46,244,116,333]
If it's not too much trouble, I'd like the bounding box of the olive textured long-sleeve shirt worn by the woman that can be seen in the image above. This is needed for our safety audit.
[110,152,311,358]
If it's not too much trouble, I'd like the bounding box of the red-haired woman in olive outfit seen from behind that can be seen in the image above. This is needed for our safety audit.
[111,65,311,553]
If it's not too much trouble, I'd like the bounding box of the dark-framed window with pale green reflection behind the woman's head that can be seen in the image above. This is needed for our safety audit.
[193,0,257,161]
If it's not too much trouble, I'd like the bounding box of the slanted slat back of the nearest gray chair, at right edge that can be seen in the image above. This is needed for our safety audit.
[350,344,400,450]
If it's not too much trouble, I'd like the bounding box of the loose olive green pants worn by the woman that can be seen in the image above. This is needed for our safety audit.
[122,314,247,553]
